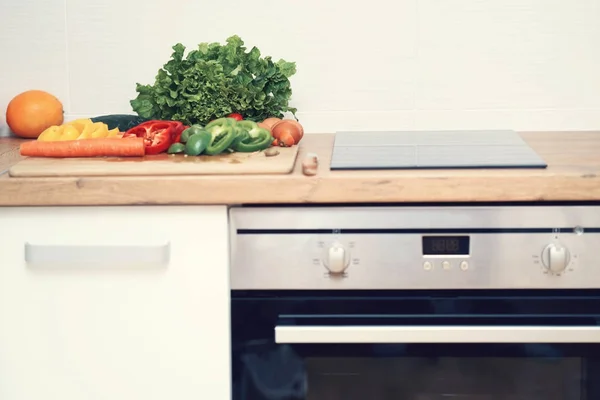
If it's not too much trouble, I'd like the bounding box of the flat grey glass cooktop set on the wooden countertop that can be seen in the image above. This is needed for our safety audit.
[330,130,548,170]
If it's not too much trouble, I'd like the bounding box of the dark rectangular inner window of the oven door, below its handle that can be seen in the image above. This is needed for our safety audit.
[306,357,582,400]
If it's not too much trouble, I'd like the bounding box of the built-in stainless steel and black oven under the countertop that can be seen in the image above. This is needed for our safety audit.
[230,204,600,400]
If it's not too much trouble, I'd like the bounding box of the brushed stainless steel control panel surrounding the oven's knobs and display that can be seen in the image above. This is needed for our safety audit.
[230,206,600,290]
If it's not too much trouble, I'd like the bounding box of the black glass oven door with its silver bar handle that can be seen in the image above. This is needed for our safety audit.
[232,291,600,400]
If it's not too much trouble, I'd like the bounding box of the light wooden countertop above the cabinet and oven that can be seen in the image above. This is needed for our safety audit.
[0,132,600,205]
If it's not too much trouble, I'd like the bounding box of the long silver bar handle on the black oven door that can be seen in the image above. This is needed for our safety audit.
[275,326,600,344]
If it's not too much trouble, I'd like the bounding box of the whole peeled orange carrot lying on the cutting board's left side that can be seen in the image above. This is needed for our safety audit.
[20,138,144,158]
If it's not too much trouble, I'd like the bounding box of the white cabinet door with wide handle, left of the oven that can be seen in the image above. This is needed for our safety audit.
[0,206,230,400]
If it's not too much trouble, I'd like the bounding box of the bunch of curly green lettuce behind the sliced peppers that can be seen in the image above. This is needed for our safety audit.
[130,35,297,125]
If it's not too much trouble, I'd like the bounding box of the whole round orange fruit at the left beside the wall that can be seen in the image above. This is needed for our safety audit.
[6,90,64,139]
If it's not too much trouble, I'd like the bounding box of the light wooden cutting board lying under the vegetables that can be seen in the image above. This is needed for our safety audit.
[8,146,298,178]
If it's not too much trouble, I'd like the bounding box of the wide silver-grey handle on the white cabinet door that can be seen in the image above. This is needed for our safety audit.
[25,242,171,267]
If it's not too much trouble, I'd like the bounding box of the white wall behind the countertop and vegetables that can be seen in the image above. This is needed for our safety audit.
[0,0,600,138]
